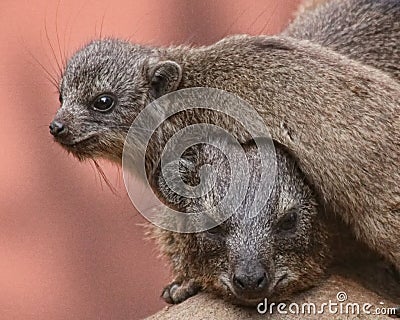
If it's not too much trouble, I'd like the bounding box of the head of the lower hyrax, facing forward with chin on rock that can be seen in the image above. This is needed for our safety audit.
[156,143,330,305]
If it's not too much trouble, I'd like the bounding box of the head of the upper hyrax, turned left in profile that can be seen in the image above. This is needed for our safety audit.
[50,39,181,162]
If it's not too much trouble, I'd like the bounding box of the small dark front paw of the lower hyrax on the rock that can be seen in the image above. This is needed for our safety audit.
[161,280,201,304]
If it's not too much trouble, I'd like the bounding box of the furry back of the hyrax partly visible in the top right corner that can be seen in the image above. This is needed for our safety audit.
[284,0,400,80]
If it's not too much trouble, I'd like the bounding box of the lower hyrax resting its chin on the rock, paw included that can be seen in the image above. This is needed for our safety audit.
[149,141,400,306]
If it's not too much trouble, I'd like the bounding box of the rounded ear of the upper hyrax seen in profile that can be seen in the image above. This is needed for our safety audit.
[148,60,182,99]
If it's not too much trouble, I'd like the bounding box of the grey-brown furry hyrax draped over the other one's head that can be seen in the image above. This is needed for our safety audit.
[51,0,400,284]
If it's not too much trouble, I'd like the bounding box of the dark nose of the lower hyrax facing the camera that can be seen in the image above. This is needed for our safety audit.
[232,264,268,294]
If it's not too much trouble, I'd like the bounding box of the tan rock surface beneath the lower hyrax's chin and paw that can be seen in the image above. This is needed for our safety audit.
[146,276,399,320]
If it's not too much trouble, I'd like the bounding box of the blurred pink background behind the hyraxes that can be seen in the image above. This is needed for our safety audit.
[0,0,298,320]
